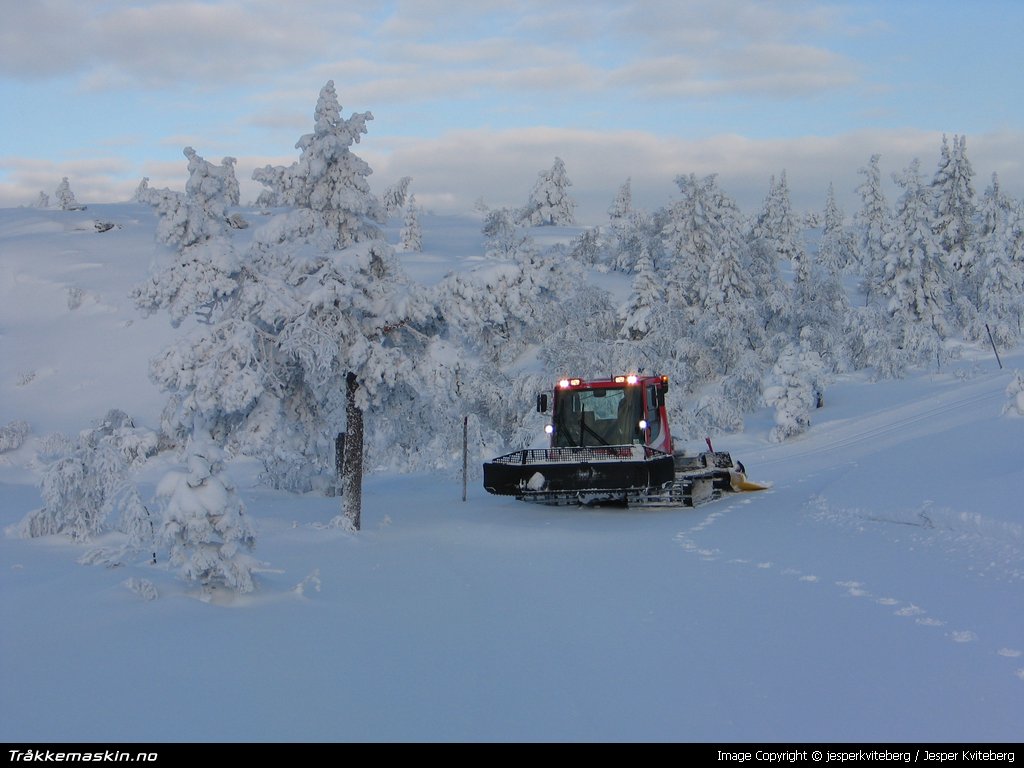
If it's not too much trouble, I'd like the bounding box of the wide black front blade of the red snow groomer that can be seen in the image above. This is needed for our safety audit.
[483,445,675,504]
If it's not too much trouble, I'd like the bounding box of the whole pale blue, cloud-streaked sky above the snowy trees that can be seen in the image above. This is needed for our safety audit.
[0,0,1024,224]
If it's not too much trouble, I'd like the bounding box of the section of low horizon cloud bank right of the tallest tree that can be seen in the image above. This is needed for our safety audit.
[360,128,1024,223]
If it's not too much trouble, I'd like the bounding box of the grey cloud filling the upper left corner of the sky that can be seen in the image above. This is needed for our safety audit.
[0,0,365,90]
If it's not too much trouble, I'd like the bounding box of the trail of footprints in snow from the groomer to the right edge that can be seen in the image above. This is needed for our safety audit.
[675,492,1024,681]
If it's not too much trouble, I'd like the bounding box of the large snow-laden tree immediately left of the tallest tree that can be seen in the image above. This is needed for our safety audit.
[133,147,297,499]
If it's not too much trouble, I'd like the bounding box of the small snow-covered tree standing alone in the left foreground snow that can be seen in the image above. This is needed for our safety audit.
[157,434,258,593]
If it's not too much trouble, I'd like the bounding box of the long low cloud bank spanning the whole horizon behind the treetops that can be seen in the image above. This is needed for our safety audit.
[0,125,1024,224]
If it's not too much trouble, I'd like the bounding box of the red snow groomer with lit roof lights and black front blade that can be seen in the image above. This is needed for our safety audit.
[483,375,767,507]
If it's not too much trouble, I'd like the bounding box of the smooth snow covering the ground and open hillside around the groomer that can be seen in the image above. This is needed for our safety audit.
[0,203,1024,743]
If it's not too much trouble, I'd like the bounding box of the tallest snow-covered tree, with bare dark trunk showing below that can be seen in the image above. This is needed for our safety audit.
[253,81,429,530]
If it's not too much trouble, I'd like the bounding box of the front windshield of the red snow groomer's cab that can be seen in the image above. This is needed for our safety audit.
[554,387,643,447]
